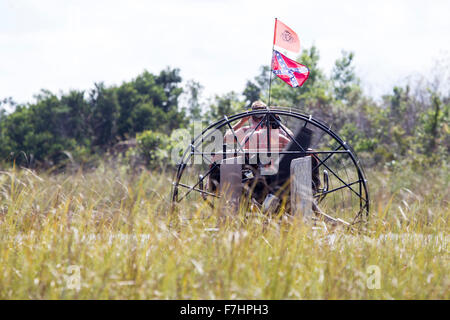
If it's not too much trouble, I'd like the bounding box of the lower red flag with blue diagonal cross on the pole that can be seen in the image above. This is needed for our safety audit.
[272,50,309,88]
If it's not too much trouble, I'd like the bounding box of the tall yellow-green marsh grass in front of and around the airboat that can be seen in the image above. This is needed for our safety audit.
[0,162,450,299]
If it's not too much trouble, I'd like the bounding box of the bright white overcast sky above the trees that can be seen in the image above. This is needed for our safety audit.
[0,0,450,102]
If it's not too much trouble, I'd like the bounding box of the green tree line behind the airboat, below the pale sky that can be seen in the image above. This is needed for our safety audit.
[0,46,450,167]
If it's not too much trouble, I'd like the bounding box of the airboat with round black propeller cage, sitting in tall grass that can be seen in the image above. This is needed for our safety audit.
[171,107,370,226]
